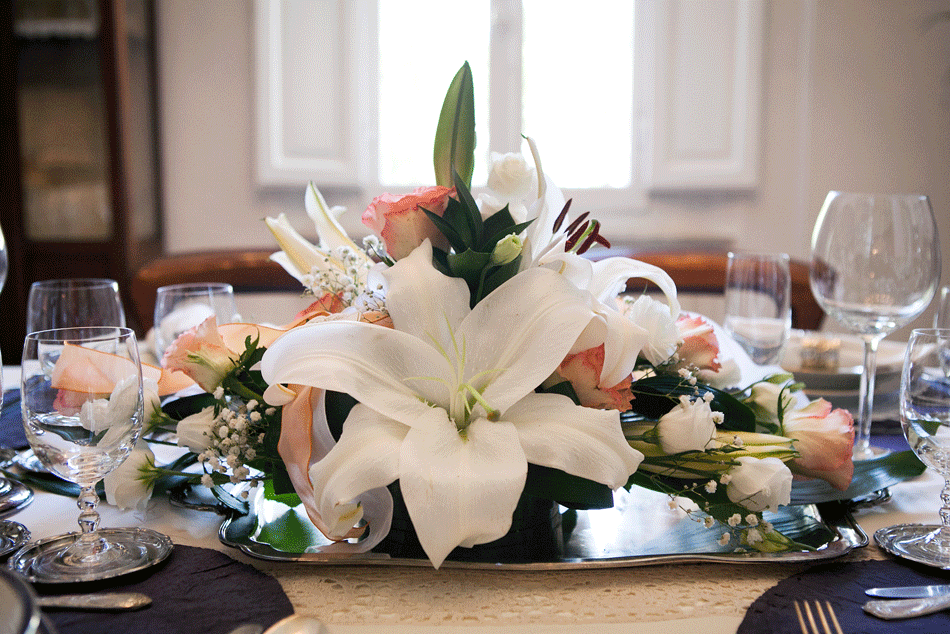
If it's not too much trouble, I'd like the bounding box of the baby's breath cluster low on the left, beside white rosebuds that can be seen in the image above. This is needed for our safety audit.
[198,398,276,499]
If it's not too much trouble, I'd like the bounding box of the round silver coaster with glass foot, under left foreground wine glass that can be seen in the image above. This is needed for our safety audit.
[10,528,172,583]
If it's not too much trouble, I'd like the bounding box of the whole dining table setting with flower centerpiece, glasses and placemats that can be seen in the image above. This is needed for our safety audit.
[0,63,950,634]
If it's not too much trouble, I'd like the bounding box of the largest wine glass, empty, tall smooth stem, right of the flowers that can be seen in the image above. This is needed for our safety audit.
[811,191,940,460]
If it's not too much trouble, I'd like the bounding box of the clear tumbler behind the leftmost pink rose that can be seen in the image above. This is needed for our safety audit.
[154,283,239,360]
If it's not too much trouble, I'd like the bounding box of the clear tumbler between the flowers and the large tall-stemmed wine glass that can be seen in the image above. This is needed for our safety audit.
[723,253,792,365]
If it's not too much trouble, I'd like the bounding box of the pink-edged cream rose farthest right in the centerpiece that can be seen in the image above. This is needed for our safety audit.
[782,398,854,491]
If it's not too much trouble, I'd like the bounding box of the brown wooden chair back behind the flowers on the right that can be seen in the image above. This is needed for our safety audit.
[594,249,825,330]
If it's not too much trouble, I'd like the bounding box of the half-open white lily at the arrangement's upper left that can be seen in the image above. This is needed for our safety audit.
[264,183,372,294]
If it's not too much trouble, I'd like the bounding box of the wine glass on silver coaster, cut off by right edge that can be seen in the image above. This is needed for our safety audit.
[874,328,950,568]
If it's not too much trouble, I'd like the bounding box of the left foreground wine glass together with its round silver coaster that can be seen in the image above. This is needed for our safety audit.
[17,327,170,583]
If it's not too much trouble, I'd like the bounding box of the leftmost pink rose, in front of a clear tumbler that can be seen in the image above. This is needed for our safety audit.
[162,315,237,392]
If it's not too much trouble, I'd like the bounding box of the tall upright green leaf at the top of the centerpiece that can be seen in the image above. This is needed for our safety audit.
[433,62,475,187]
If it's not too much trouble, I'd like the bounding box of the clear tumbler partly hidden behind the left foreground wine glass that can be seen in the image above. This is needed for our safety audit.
[26,278,125,332]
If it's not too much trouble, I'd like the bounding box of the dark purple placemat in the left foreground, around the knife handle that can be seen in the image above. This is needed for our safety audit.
[36,545,294,634]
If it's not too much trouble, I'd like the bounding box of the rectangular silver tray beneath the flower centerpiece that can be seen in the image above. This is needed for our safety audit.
[219,488,868,570]
